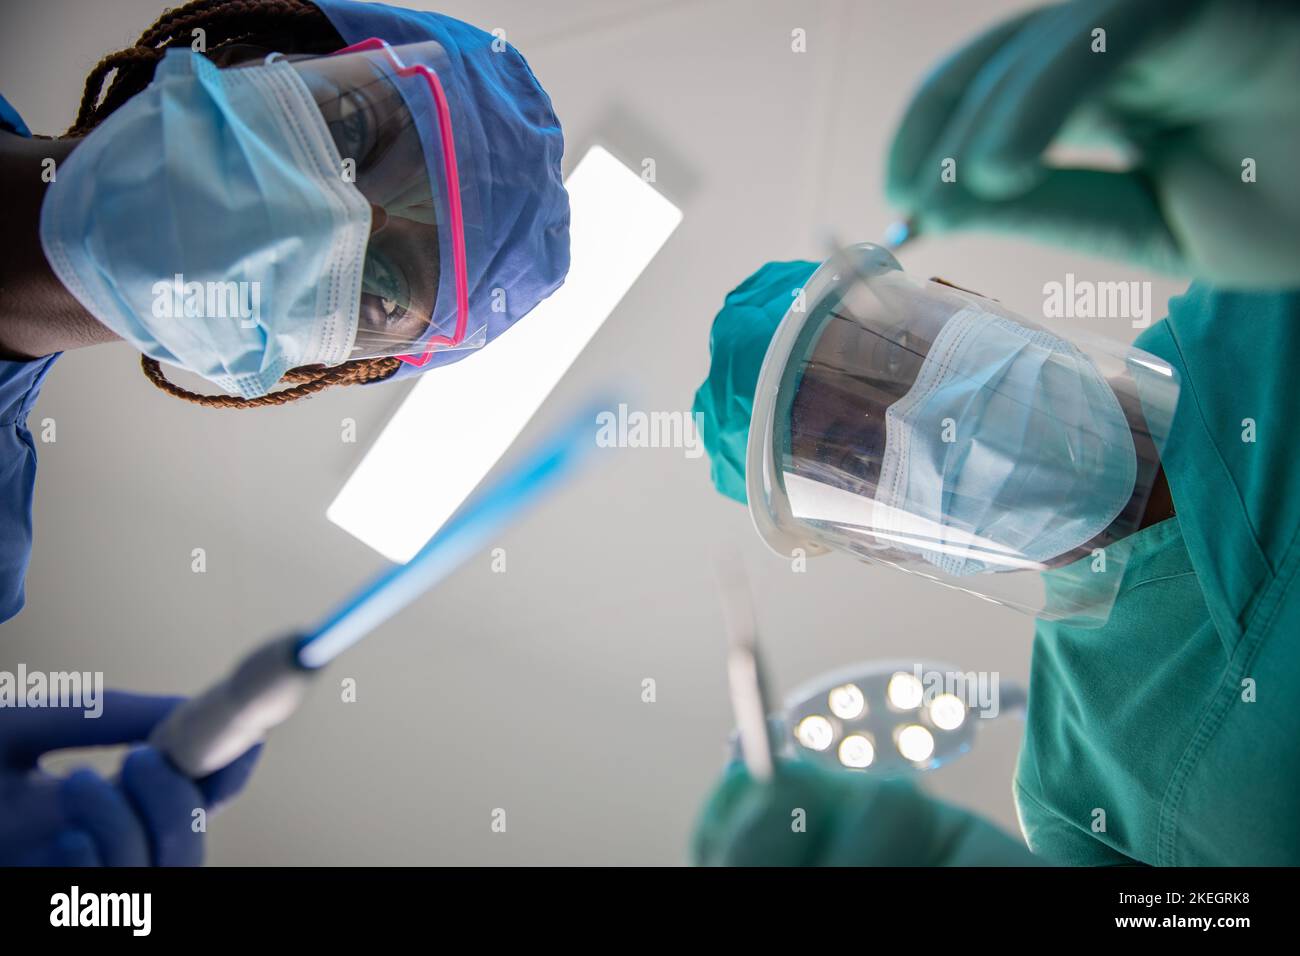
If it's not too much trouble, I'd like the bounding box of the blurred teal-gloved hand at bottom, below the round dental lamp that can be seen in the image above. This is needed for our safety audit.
[692,762,1040,866]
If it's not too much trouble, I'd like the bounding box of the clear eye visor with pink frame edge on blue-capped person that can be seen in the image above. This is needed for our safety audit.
[271,39,486,365]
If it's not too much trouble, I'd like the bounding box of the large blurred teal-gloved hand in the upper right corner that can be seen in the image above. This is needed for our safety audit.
[885,0,1300,287]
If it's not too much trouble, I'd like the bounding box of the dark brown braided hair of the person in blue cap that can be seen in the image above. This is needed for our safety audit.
[65,0,402,408]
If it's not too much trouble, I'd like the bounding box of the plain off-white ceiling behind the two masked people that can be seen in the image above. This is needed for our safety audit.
[0,0,1177,864]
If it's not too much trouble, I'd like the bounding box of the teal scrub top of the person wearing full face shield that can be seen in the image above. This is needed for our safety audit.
[1015,284,1300,866]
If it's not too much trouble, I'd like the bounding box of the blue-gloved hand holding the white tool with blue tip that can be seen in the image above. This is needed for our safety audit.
[0,691,261,866]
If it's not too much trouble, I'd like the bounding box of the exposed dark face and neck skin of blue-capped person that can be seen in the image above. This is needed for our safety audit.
[0,44,438,360]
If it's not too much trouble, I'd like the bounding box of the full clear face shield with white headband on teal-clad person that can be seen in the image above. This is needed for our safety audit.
[746,245,1179,624]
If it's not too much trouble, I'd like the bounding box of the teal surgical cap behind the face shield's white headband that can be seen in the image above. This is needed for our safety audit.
[694,261,819,505]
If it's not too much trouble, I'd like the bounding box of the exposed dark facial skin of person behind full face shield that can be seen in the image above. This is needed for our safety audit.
[790,282,1174,567]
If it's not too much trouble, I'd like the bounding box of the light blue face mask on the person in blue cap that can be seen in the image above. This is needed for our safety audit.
[40,49,371,398]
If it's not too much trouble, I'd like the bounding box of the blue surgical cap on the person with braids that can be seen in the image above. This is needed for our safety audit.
[313,0,569,381]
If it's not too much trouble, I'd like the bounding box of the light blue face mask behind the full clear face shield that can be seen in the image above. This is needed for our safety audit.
[875,308,1138,575]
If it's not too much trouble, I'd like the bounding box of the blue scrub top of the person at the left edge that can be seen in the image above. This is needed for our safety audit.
[0,96,61,622]
